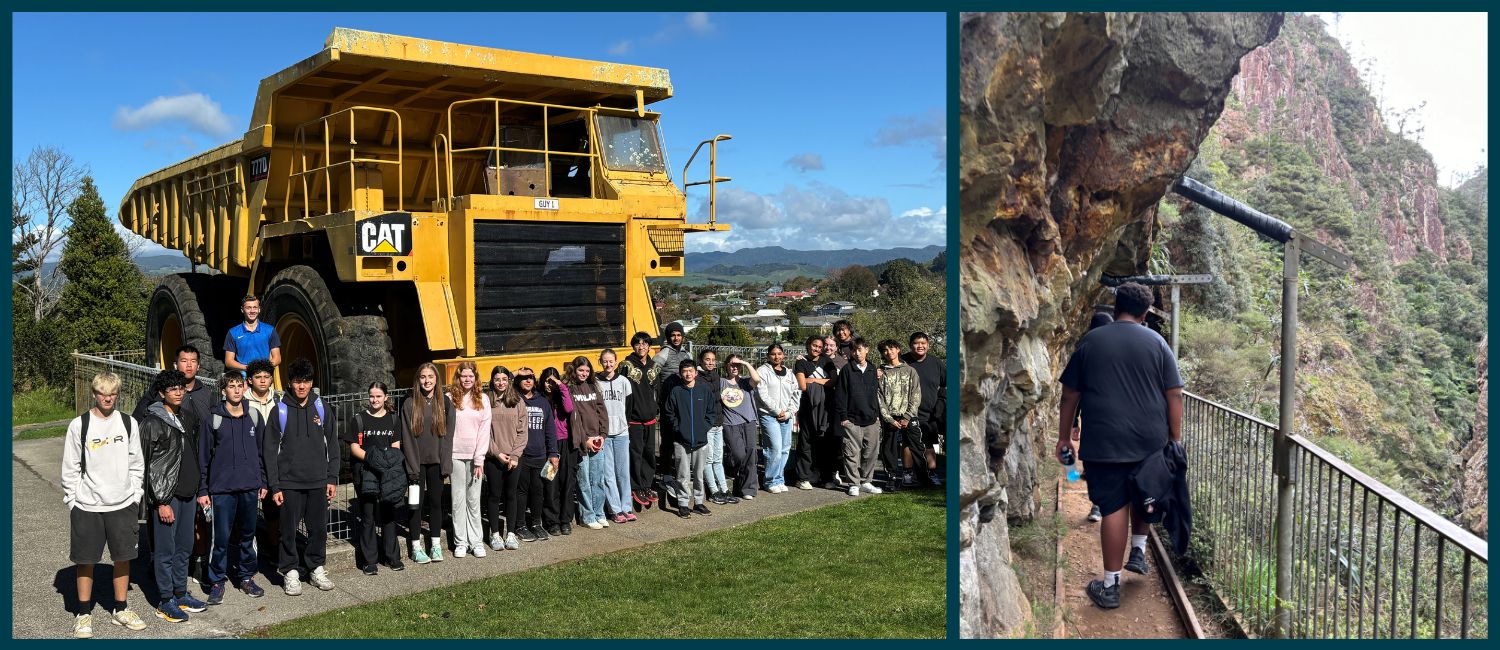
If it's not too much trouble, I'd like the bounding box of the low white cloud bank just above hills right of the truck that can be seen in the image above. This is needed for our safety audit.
[689,183,948,252]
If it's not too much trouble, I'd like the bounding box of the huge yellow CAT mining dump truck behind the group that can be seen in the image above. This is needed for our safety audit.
[120,29,729,393]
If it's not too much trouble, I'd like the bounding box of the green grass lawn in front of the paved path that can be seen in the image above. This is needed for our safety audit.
[257,489,948,638]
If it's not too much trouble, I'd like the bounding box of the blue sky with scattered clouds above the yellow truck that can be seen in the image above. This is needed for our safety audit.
[12,14,947,254]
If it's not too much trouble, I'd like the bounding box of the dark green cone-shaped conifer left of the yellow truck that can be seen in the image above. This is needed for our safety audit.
[57,177,146,351]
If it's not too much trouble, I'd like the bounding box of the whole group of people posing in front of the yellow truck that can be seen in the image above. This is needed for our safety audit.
[62,297,945,636]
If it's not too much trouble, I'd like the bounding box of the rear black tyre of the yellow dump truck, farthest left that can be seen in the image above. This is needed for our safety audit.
[146,273,224,378]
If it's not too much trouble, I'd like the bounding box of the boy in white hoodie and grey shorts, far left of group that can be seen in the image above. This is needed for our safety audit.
[62,372,146,638]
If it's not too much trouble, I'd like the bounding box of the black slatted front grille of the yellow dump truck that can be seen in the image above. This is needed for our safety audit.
[474,221,626,354]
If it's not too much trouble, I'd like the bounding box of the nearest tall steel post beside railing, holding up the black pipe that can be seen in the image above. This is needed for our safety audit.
[1272,237,1301,638]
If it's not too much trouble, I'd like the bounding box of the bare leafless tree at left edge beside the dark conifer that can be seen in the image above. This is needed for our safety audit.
[11,147,89,323]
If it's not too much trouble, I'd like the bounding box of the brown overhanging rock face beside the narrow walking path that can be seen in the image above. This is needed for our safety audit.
[959,14,1283,636]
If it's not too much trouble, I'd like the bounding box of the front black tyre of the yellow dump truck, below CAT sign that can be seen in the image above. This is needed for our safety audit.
[261,266,396,395]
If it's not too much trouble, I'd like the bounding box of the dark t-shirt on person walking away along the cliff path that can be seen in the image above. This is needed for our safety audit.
[1061,321,1182,462]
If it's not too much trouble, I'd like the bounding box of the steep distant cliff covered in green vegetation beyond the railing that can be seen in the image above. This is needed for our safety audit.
[1152,17,1488,516]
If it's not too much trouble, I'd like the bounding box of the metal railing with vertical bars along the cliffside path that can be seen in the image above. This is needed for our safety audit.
[1182,393,1490,638]
